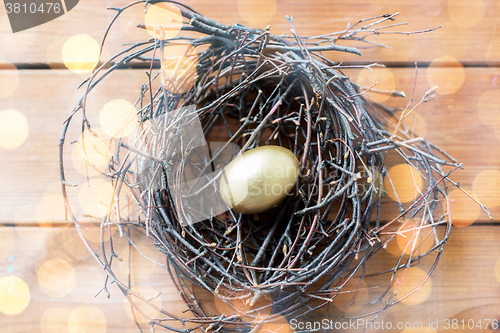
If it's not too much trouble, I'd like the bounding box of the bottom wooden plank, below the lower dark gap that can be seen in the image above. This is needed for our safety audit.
[0,226,500,333]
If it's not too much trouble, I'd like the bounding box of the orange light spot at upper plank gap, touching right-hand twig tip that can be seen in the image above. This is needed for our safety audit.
[356,67,396,102]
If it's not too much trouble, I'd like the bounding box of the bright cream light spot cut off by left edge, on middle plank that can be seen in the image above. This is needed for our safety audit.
[0,109,30,149]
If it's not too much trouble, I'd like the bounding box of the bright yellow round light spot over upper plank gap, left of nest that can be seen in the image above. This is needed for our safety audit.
[62,35,100,73]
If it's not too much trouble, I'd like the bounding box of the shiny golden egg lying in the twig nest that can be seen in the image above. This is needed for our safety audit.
[219,146,300,214]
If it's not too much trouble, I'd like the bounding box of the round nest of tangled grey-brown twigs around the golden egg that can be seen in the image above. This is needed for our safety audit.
[61,1,480,332]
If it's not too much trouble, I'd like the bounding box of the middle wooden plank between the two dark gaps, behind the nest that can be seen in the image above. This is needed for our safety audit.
[0,68,500,223]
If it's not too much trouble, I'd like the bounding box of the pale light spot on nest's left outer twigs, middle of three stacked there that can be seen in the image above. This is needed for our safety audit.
[71,127,115,176]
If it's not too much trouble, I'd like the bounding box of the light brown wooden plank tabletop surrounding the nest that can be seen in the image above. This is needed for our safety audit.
[0,0,500,333]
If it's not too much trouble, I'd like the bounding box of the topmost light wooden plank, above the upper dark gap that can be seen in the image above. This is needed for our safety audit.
[0,0,500,65]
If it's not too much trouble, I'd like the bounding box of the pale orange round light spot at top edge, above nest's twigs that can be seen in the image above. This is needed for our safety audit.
[144,3,183,40]
